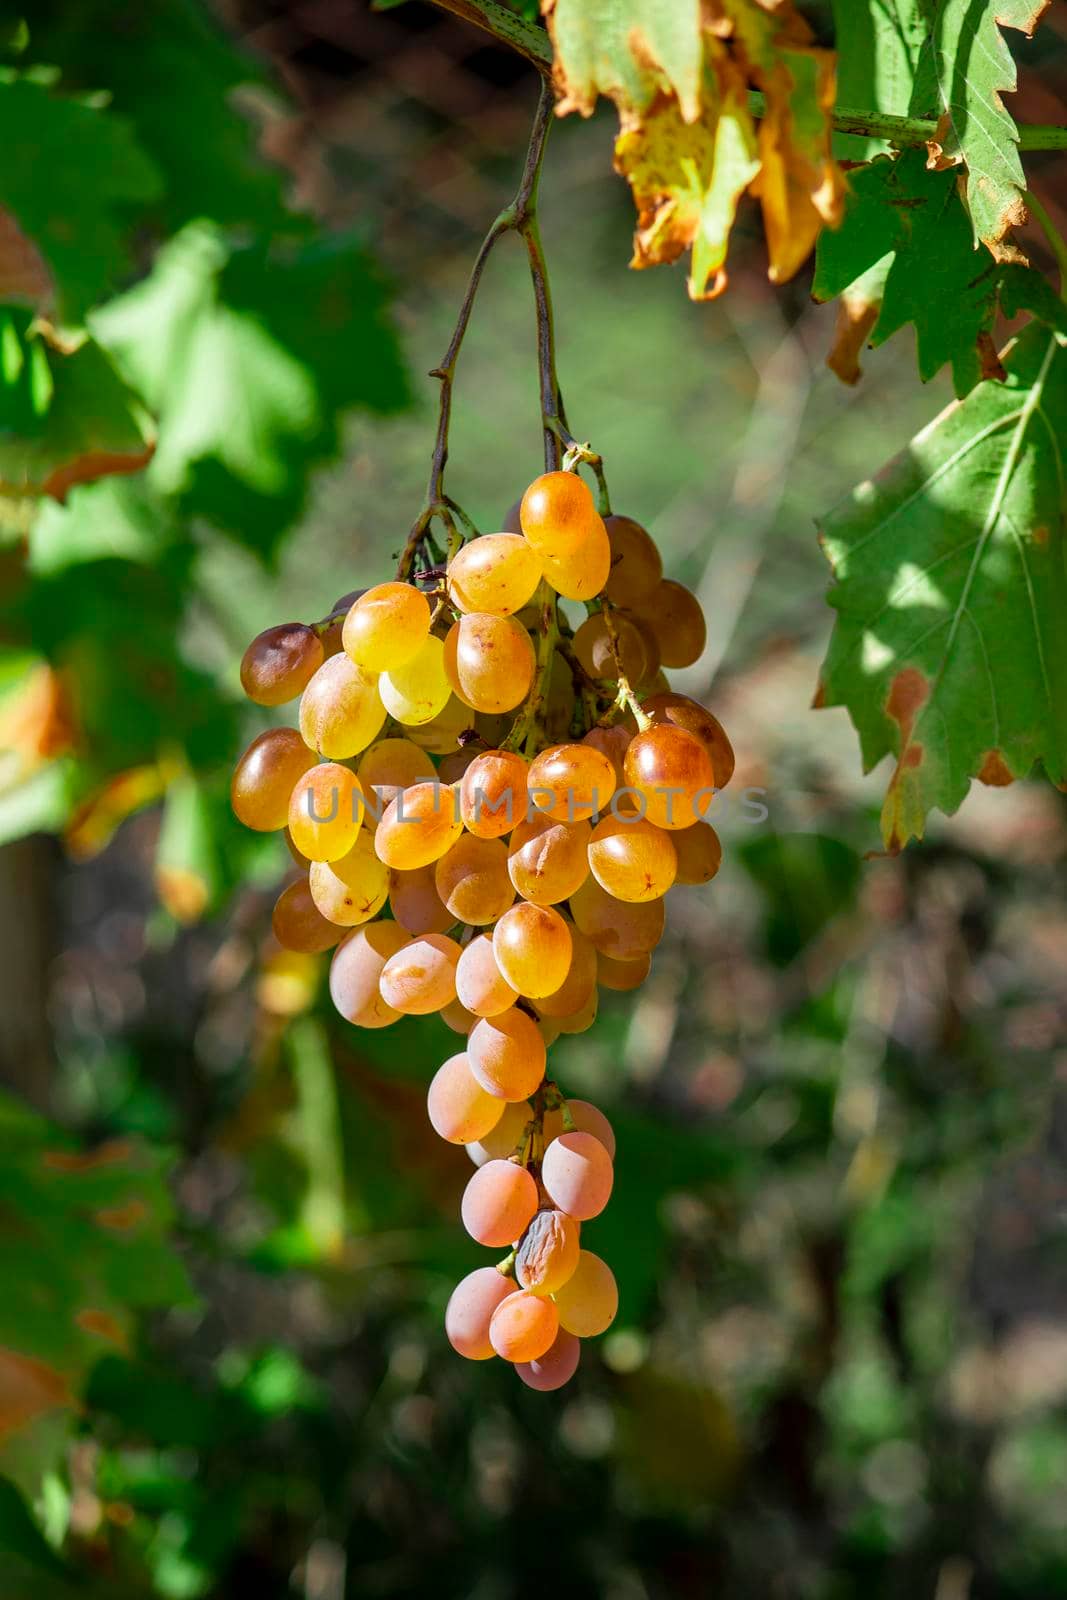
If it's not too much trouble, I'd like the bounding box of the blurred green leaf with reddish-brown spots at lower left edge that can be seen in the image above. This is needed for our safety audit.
[0,1096,194,1470]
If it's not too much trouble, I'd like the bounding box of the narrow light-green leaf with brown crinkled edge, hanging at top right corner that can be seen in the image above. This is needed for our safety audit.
[912,0,1051,261]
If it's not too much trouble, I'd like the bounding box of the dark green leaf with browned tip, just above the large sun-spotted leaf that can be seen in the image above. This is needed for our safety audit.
[811,150,1064,397]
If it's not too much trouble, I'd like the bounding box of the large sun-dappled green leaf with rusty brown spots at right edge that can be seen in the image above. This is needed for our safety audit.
[816,323,1067,851]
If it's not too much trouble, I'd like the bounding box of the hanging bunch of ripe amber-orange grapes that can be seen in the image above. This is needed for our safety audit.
[232,470,733,1389]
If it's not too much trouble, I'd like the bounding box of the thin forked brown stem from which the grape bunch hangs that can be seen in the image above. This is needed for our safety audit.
[397,76,575,582]
